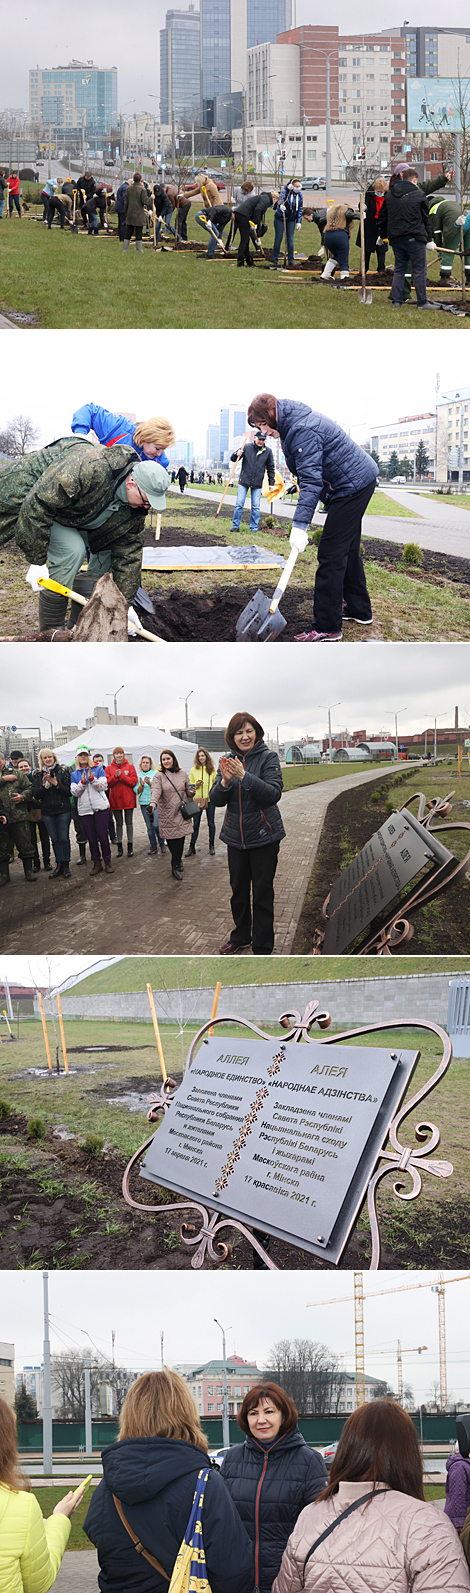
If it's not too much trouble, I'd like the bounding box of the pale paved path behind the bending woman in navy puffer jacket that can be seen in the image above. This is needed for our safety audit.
[170,487,470,559]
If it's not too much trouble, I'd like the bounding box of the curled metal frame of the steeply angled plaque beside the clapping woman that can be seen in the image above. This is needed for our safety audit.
[312,792,470,957]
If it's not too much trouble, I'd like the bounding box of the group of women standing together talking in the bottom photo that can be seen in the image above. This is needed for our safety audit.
[0,1368,470,1593]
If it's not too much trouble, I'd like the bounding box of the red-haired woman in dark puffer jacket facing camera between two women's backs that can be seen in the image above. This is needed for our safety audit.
[221,1383,327,1593]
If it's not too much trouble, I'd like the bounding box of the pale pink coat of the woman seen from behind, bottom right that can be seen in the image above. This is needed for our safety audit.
[272,1483,470,1593]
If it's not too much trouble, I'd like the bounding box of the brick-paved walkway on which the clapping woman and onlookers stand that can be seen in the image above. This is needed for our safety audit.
[2,765,404,957]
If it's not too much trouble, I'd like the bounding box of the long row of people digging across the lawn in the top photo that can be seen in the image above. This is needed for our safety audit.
[0,161,470,309]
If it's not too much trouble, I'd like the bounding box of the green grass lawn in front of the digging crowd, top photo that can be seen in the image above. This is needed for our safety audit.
[0,212,470,331]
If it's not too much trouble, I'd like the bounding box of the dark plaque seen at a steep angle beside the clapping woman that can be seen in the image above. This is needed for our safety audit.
[322,808,454,956]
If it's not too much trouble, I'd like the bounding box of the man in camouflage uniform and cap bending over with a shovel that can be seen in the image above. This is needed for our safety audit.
[0,436,169,629]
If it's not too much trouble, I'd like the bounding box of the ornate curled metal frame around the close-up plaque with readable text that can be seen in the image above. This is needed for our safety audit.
[123,1000,454,1271]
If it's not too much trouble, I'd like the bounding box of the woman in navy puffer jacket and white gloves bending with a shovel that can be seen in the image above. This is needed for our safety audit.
[247,393,379,642]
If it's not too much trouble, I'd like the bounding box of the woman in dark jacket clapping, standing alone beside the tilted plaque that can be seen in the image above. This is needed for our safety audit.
[210,714,285,956]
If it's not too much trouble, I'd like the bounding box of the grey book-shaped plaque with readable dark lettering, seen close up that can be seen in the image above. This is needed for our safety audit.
[134,1032,419,1263]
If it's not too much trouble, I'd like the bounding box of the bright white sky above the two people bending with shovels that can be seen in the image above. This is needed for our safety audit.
[0,331,468,452]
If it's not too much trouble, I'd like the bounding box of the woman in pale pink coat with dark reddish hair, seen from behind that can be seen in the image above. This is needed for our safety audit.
[272,1400,470,1593]
